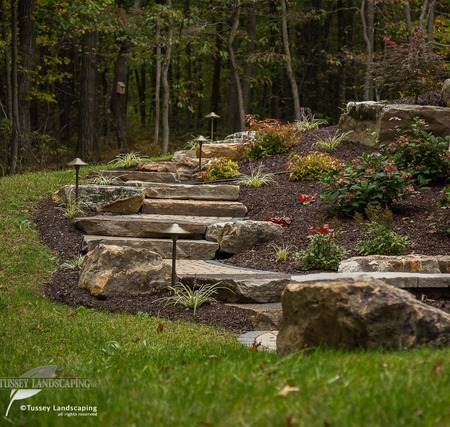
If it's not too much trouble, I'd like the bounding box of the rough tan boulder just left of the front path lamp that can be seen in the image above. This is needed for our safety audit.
[78,244,171,297]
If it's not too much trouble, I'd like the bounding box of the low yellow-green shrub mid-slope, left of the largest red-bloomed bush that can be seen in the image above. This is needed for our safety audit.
[287,151,341,181]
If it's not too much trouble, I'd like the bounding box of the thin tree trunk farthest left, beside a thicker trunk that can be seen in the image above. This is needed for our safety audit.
[8,0,19,175]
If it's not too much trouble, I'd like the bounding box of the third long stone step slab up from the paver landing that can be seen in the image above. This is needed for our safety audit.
[142,199,247,217]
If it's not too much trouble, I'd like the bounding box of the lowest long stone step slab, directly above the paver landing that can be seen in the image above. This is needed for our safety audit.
[82,235,219,259]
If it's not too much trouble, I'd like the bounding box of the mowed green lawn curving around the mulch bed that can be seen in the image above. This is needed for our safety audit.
[0,170,450,427]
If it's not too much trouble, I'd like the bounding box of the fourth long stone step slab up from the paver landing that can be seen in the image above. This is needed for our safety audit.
[127,181,239,201]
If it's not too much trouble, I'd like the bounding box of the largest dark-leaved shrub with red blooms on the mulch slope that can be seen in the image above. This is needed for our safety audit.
[320,153,415,215]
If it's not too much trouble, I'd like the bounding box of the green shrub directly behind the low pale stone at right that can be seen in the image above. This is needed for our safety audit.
[355,205,413,256]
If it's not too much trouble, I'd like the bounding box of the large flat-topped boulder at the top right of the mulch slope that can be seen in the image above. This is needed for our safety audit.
[338,101,450,146]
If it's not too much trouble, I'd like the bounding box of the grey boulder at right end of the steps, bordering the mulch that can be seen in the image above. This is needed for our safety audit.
[205,220,284,254]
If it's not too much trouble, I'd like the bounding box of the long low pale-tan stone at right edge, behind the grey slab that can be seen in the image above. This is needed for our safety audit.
[338,254,450,274]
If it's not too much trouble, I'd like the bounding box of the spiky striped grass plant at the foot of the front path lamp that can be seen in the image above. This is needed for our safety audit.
[158,282,224,316]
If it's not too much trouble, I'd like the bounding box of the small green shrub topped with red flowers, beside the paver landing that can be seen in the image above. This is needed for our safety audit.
[294,224,347,271]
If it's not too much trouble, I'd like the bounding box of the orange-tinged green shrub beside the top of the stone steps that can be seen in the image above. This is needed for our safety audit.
[246,114,300,160]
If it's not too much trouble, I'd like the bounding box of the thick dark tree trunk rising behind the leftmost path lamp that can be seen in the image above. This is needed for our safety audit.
[77,31,98,159]
